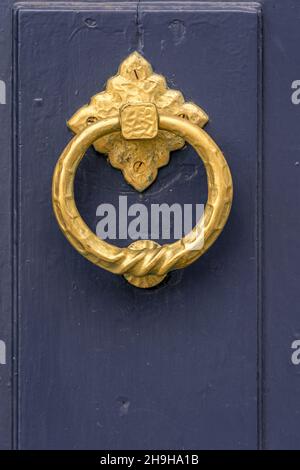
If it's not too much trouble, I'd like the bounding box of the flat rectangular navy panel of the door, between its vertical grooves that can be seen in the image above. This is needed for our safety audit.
[14,2,260,449]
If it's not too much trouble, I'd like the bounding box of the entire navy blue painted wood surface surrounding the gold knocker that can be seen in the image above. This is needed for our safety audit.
[0,0,300,449]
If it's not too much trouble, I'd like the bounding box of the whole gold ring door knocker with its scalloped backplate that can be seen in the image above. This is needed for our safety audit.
[52,52,233,288]
